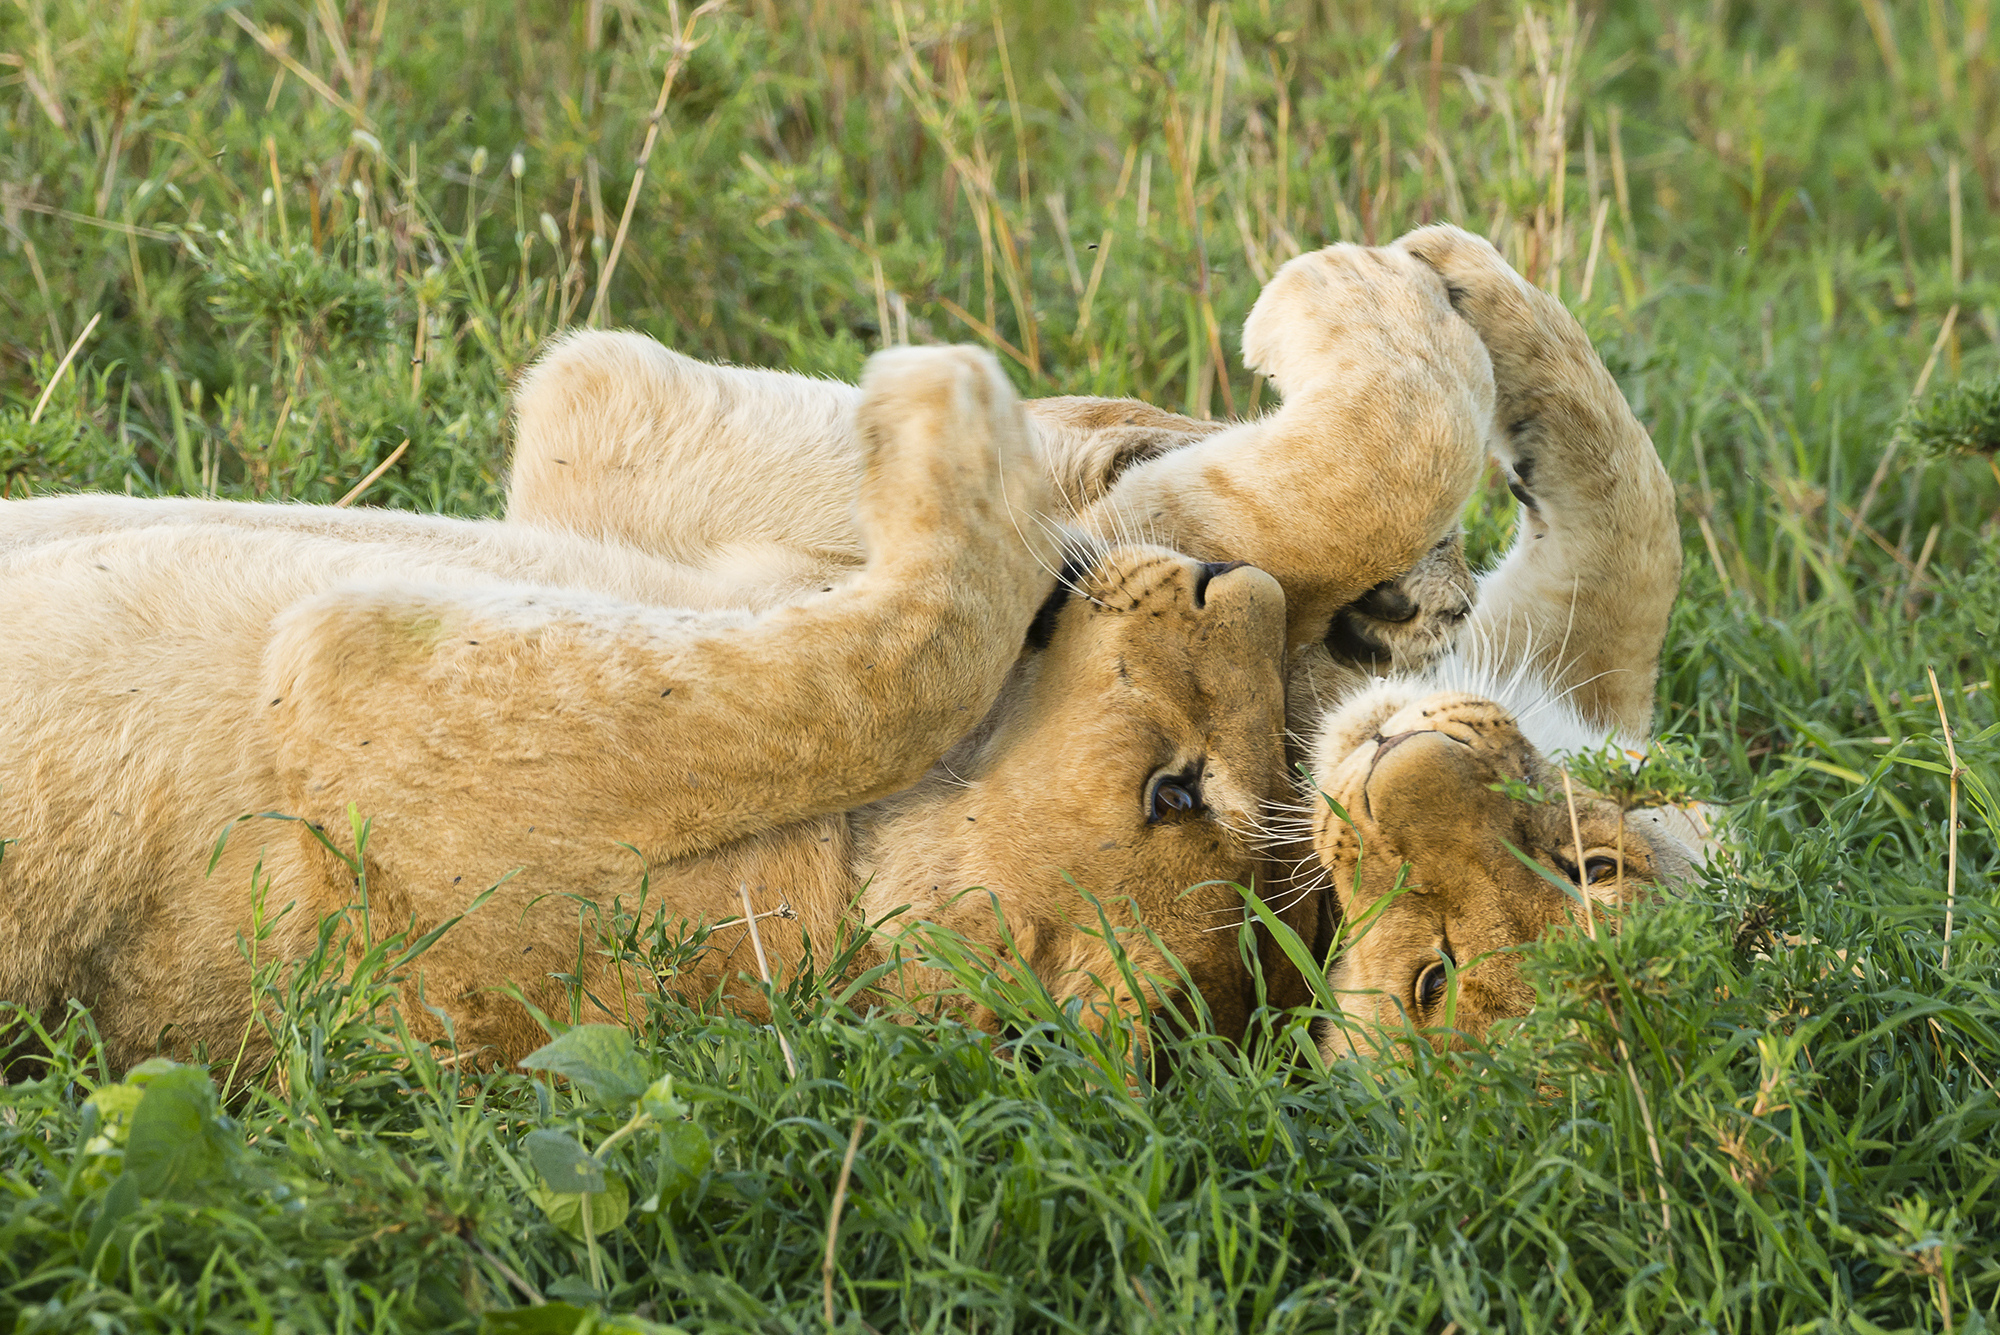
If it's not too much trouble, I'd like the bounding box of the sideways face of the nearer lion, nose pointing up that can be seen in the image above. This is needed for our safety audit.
[864,546,1284,1033]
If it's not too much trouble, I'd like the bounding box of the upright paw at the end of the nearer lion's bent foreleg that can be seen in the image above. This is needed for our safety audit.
[854,348,1056,566]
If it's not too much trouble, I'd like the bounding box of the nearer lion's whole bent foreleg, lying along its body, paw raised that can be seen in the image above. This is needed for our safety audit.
[284,348,1056,859]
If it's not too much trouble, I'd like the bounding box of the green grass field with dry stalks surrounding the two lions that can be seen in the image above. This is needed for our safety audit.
[0,0,2000,1335]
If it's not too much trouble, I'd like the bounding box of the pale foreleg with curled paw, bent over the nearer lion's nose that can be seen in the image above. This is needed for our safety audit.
[1086,246,1492,652]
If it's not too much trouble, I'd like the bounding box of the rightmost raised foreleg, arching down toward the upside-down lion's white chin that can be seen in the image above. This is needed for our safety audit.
[1396,226,1680,737]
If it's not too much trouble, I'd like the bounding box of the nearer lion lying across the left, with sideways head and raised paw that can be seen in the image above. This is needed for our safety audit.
[0,350,1284,1063]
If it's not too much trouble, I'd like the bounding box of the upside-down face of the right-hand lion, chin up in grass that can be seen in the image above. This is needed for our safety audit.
[1312,683,1690,1057]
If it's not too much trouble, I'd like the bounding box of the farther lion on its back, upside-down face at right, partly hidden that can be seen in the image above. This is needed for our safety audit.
[508,228,1704,1055]
